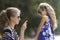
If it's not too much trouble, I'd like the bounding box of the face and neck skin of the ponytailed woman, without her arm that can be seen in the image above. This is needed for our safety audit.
[9,12,21,28]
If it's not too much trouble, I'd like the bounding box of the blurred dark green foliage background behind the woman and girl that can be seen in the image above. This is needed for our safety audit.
[0,0,60,37]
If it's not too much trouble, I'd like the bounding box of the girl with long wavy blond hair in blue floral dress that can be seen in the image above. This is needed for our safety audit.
[35,3,57,40]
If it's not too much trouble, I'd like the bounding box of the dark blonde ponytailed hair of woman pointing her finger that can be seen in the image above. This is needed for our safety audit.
[0,7,20,33]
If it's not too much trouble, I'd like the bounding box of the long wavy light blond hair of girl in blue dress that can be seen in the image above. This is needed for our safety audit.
[38,3,57,30]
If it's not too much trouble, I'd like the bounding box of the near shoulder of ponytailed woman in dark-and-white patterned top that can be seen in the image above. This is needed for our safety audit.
[3,27,15,40]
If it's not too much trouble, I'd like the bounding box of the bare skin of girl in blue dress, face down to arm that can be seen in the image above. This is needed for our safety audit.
[34,9,48,40]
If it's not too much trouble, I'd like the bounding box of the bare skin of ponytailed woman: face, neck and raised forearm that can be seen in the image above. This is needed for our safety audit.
[9,12,27,40]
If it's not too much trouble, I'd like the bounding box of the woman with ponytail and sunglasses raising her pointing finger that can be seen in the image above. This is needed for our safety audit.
[0,7,27,40]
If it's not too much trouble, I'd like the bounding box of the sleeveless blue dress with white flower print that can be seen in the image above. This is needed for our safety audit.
[38,17,54,40]
